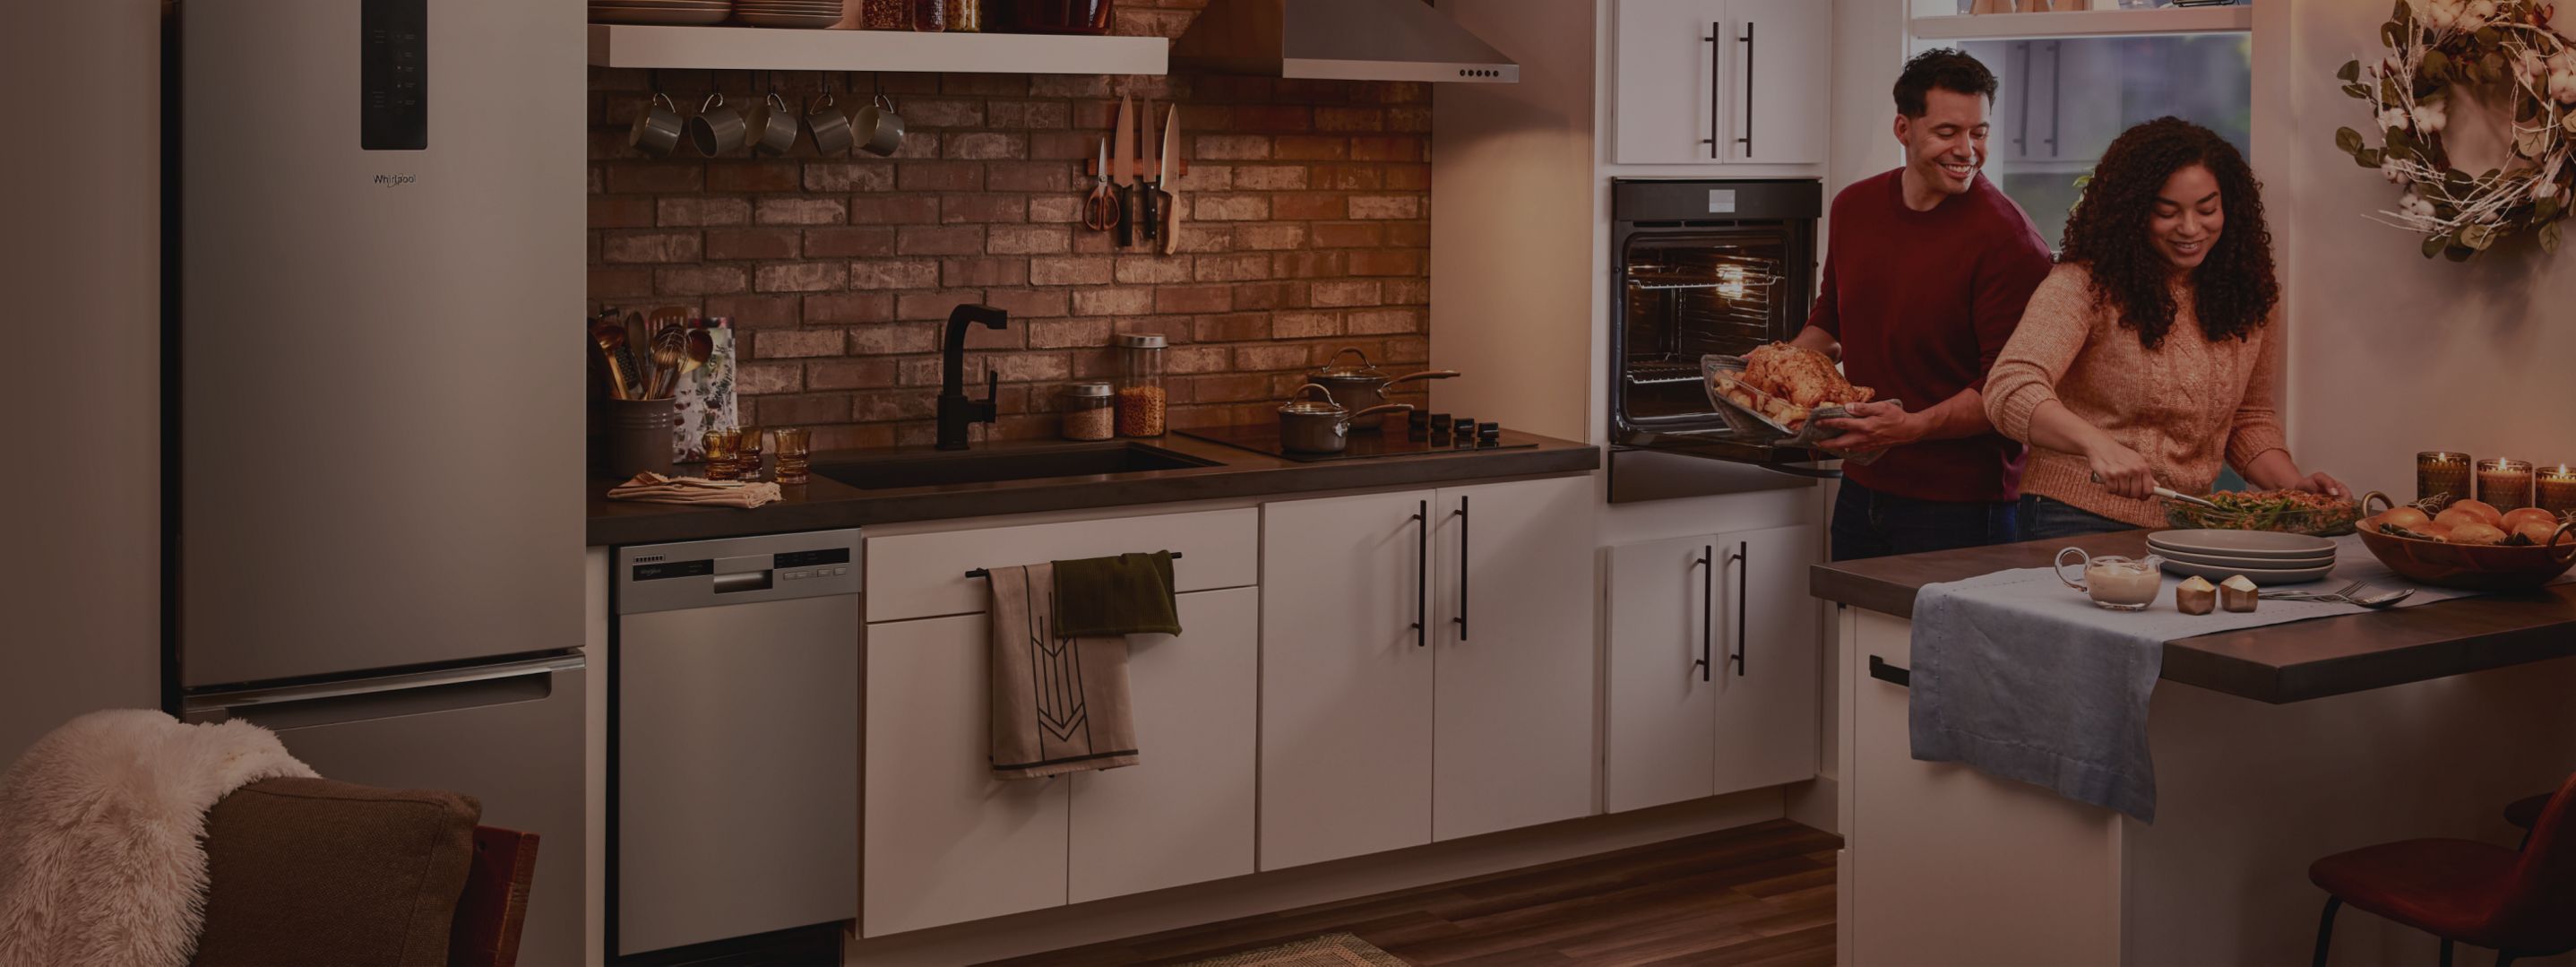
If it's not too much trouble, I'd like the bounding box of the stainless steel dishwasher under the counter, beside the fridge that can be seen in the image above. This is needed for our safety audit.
[608,531,860,954]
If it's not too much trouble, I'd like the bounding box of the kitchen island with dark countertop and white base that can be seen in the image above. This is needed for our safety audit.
[1811,531,2576,964]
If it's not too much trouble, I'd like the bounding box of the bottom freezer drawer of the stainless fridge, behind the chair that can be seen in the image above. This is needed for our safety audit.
[185,655,585,964]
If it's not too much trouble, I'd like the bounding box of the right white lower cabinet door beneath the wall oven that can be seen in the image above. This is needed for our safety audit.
[1716,526,1824,794]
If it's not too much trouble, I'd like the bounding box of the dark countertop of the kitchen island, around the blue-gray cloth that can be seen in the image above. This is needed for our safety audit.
[1808,531,2576,704]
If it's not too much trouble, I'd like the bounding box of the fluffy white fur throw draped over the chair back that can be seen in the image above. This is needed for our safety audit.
[0,709,314,967]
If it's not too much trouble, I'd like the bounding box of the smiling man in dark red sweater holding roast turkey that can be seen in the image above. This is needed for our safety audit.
[1796,49,2051,559]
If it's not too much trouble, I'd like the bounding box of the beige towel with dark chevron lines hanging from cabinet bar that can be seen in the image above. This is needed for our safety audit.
[989,565,1136,779]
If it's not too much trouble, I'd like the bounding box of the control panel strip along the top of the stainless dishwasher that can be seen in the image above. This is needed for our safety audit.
[616,529,863,614]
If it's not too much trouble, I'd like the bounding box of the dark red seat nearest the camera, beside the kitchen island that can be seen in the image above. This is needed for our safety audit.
[2308,776,2576,967]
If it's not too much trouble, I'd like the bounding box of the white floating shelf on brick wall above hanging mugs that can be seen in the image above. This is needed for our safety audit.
[590,23,1172,74]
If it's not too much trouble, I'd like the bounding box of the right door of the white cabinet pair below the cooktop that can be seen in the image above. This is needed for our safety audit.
[1433,477,1599,841]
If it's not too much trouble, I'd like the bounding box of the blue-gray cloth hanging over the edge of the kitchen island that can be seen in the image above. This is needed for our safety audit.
[1907,536,2514,823]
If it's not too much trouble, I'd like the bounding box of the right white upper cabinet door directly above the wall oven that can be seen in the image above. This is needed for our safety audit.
[1719,0,1834,165]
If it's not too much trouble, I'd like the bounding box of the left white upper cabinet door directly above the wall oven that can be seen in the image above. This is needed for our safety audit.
[1610,0,1728,165]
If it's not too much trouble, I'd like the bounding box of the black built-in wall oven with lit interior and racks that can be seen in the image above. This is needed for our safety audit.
[1607,178,1834,503]
